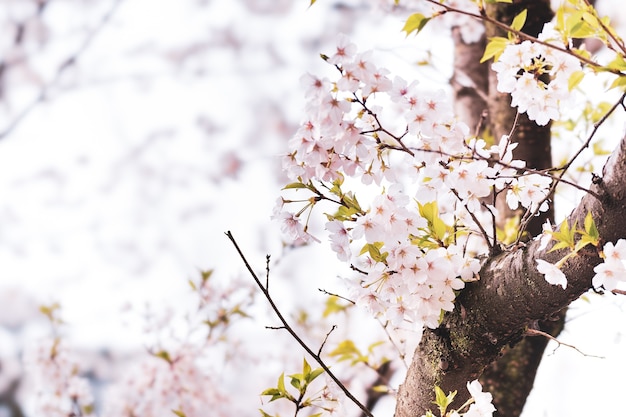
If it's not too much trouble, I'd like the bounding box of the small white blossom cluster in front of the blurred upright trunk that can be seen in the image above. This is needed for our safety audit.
[491,23,581,126]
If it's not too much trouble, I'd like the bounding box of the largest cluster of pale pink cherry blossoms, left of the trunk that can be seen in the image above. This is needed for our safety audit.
[274,37,551,329]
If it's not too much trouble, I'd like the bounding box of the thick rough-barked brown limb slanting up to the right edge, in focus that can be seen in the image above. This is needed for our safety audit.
[396,133,626,417]
